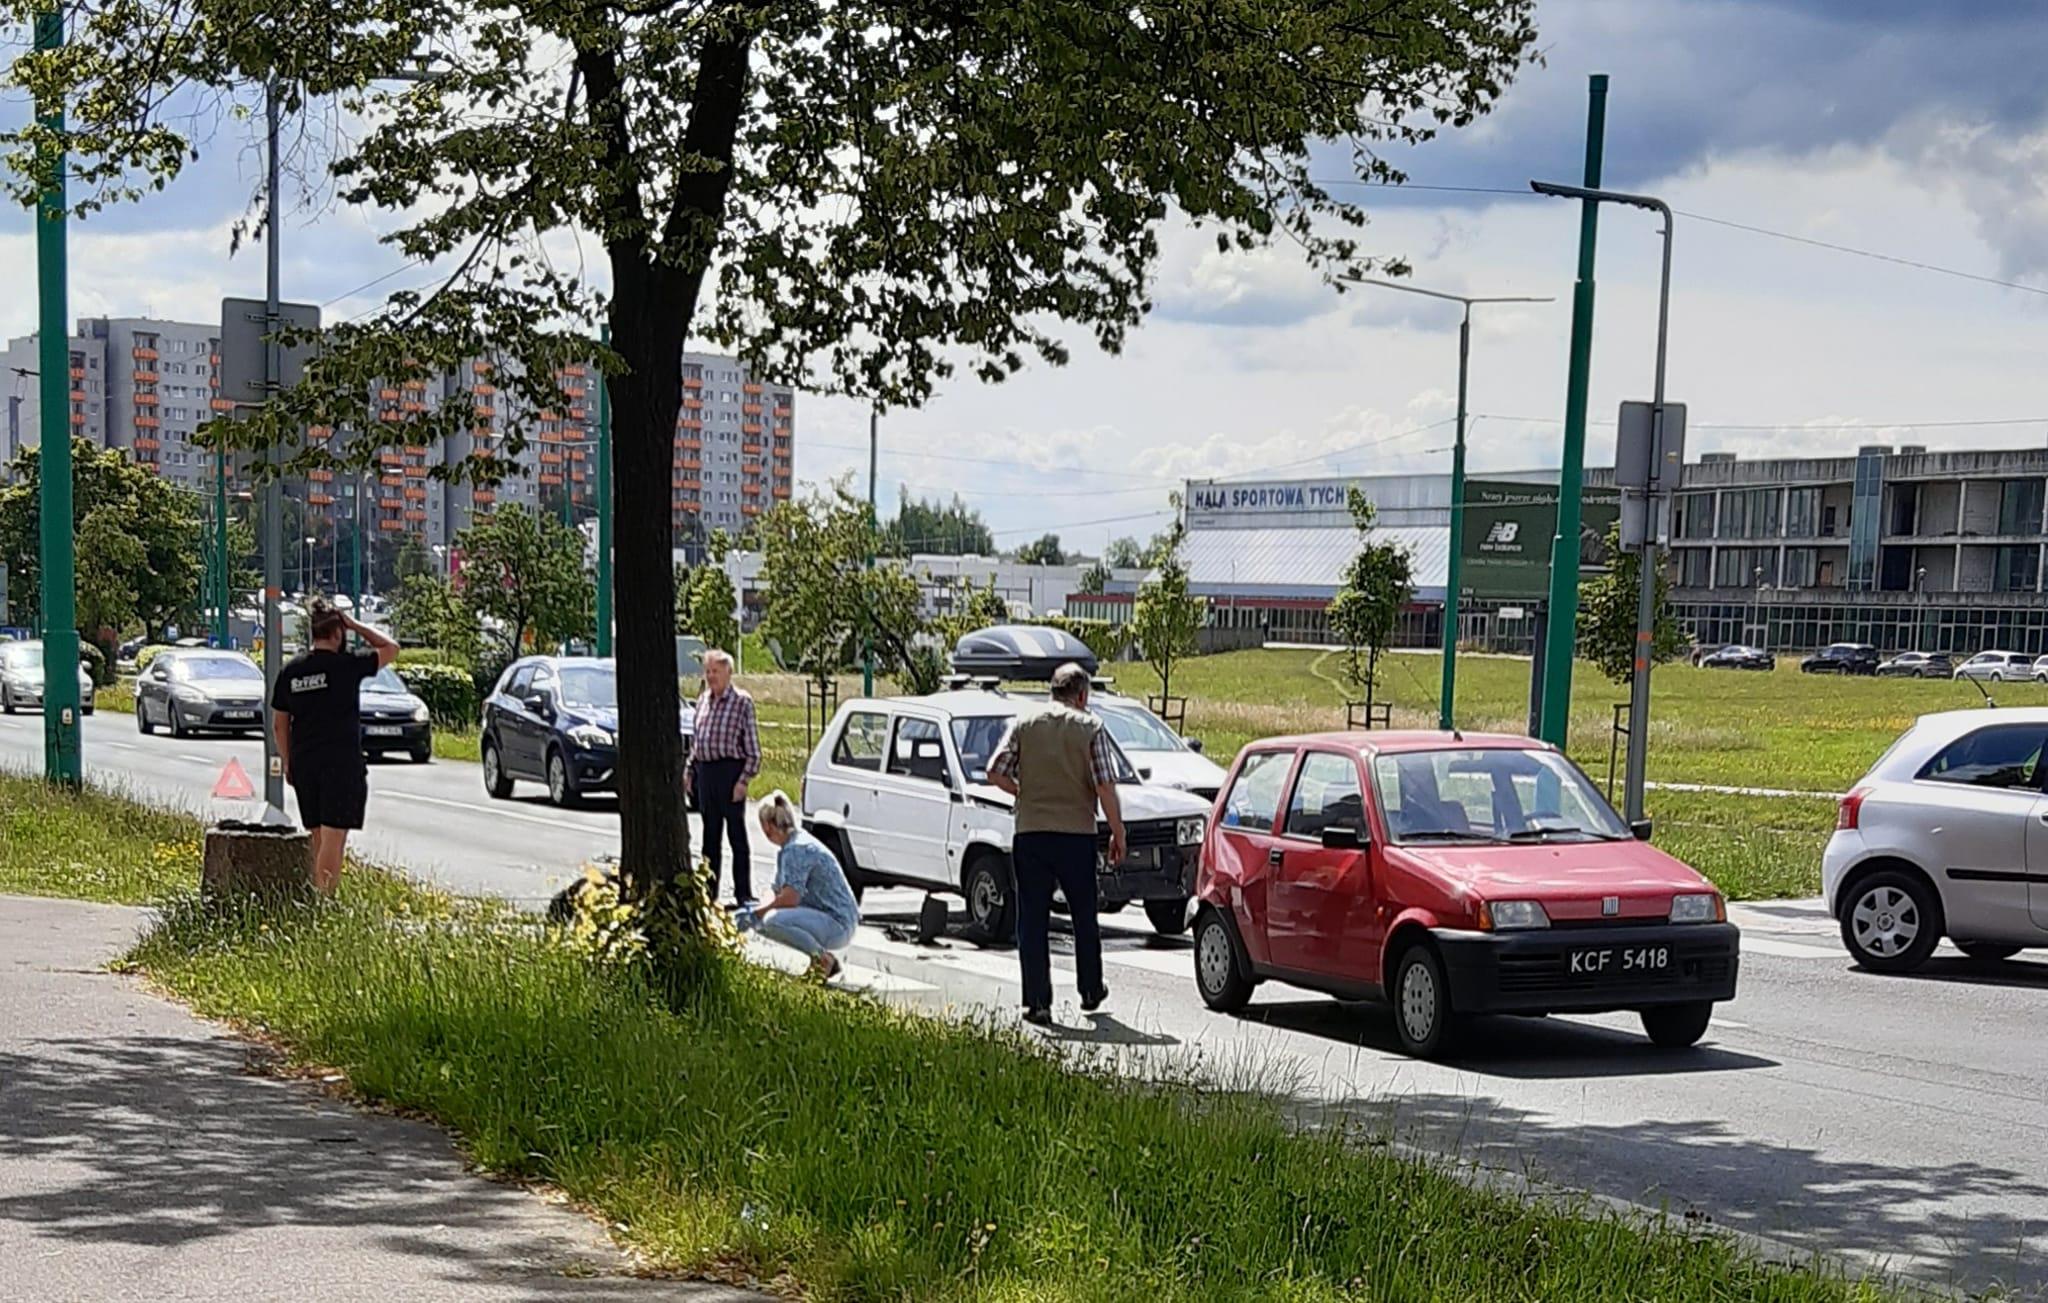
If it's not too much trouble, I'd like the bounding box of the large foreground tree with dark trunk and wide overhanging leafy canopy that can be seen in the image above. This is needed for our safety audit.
[12,0,1536,959]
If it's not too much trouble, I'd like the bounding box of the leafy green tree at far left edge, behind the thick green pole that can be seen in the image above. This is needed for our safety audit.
[0,438,205,641]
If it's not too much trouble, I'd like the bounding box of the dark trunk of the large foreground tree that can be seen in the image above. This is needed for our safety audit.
[606,250,702,905]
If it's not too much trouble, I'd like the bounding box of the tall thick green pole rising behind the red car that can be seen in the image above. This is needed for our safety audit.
[1542,72,1608,748]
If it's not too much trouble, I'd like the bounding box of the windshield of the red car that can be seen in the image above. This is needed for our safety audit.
[1372,748,1628,842]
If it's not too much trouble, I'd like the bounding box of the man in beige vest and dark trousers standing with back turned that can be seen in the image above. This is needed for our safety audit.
[989,664,1124,1026]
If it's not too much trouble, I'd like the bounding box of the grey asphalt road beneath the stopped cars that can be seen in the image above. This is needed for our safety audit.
[0,715,2048,1297]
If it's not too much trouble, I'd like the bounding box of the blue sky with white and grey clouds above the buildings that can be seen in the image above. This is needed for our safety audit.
[0,0,2048,547]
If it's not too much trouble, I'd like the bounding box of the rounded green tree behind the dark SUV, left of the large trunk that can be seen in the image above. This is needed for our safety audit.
[455,506,593,655]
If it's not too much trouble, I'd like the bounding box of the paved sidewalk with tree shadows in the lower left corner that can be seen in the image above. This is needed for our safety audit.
[0,895,758,1303]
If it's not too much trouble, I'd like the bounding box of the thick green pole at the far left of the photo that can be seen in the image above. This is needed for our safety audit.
[35,2,84,787]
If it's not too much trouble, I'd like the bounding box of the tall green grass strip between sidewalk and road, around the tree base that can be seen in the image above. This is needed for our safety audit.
[133,860,1884,1303]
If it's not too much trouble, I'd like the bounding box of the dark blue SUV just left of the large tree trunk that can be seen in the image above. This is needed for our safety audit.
[479,656,618,805]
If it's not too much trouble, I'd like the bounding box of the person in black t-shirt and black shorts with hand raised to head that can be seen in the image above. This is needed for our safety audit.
[270,600,397,895]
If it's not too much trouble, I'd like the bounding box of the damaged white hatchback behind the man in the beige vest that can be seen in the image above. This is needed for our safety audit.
[801,690,1208,938]
